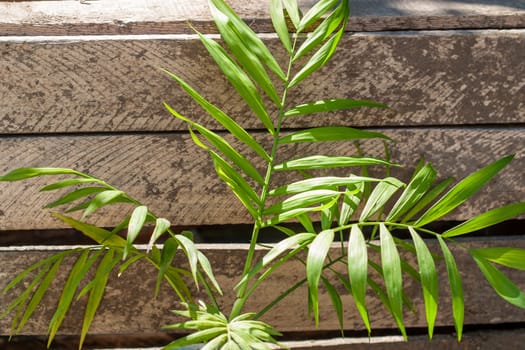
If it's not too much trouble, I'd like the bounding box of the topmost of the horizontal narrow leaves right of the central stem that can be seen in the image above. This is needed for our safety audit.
[284,98,387,117]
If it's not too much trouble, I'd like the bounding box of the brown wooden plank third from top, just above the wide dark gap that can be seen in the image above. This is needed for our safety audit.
[0,127,525,230]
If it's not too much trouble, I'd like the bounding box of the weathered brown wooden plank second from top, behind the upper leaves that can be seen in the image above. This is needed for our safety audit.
[0,30,525,134]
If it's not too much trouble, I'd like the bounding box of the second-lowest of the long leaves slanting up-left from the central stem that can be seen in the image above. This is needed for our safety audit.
[165,104,264,184]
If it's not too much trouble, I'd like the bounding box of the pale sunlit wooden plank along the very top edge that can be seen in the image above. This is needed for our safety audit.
[0,0,525,35]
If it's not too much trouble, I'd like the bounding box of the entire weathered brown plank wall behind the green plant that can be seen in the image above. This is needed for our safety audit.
[0,0,525,349]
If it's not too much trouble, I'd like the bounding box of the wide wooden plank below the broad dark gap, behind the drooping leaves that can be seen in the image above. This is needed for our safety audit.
[0,236,525,335]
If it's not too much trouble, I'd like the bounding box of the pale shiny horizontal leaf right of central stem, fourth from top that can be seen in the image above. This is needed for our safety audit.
[268,176,376,196]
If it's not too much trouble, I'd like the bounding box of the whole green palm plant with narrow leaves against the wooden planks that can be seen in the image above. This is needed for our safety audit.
[1,0,525,349]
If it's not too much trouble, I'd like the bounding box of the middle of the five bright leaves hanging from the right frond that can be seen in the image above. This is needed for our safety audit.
[379,224,405,333]
